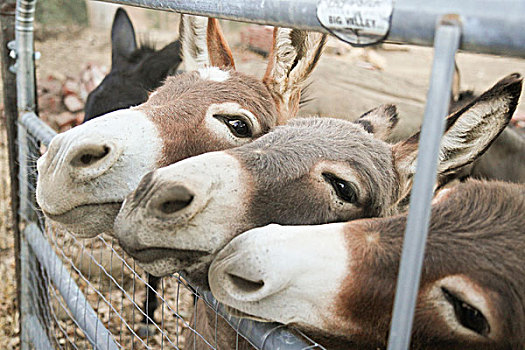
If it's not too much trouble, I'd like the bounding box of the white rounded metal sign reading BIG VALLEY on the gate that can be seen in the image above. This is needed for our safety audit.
[317,0,394,46]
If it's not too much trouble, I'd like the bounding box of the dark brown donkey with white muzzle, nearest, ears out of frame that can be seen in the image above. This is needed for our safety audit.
[209,180,525,349]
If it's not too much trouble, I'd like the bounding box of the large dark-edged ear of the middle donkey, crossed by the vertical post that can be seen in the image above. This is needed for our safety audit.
[394,73,523,182]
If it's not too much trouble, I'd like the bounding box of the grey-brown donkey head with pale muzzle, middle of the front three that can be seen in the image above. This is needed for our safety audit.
[115,74,522,283]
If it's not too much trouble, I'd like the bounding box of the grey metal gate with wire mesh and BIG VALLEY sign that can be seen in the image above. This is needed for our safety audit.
[3,0,525,349]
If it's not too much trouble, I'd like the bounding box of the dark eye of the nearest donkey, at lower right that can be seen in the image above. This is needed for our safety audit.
[441,287,490,336]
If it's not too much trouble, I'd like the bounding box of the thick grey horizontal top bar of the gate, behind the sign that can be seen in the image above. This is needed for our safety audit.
[93,0,525,58]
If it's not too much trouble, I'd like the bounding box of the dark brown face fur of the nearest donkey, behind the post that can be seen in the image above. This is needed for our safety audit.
[334,180,525,349]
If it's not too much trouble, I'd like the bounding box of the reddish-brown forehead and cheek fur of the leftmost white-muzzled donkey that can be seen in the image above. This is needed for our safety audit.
[138,70,277,167]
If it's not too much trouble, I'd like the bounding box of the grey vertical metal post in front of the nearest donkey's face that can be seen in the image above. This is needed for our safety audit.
[388,16,461,350]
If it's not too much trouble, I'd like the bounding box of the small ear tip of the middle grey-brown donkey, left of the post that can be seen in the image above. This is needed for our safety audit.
[355,105,399,141]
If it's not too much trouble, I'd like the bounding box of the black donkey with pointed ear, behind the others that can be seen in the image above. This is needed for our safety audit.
[84,8,182,122]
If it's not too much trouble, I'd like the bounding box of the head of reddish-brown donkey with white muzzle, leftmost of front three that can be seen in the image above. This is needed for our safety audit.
[37,17,326,237]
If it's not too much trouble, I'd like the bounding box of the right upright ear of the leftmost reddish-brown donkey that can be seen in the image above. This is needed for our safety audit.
[263,28,326,124]
